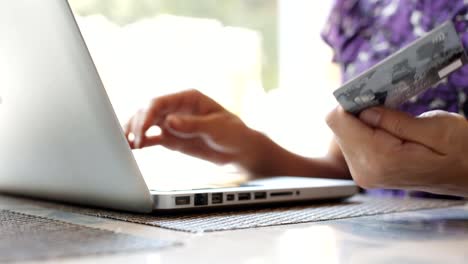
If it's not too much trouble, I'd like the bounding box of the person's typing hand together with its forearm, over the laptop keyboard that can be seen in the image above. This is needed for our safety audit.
[124,90,354,178]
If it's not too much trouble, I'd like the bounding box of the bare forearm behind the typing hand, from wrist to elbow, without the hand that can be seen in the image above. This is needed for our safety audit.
[239,131,350,178]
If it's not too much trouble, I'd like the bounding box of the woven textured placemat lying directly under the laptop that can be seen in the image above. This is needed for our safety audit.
[3,196,465,233]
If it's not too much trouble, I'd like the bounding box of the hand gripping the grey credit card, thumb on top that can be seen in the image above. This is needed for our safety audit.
[327,108,468,197]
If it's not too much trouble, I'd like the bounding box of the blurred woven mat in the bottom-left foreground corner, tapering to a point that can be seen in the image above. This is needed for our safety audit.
[0,210,175,262]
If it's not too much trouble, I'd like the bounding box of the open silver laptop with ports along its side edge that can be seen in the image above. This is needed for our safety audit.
[0,0,358,213]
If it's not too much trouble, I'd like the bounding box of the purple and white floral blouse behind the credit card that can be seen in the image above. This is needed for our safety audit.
[322,0,468,196]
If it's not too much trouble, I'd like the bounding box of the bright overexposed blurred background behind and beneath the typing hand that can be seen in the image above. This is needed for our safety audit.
[69,0,340,189]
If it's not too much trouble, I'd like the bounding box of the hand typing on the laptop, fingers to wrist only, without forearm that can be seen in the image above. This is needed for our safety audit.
[124,90,257,164]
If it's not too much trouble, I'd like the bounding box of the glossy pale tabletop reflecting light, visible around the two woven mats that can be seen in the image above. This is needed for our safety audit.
[0,196,468,264]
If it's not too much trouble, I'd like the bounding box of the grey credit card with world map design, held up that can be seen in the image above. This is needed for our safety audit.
[333,21,468,114]
